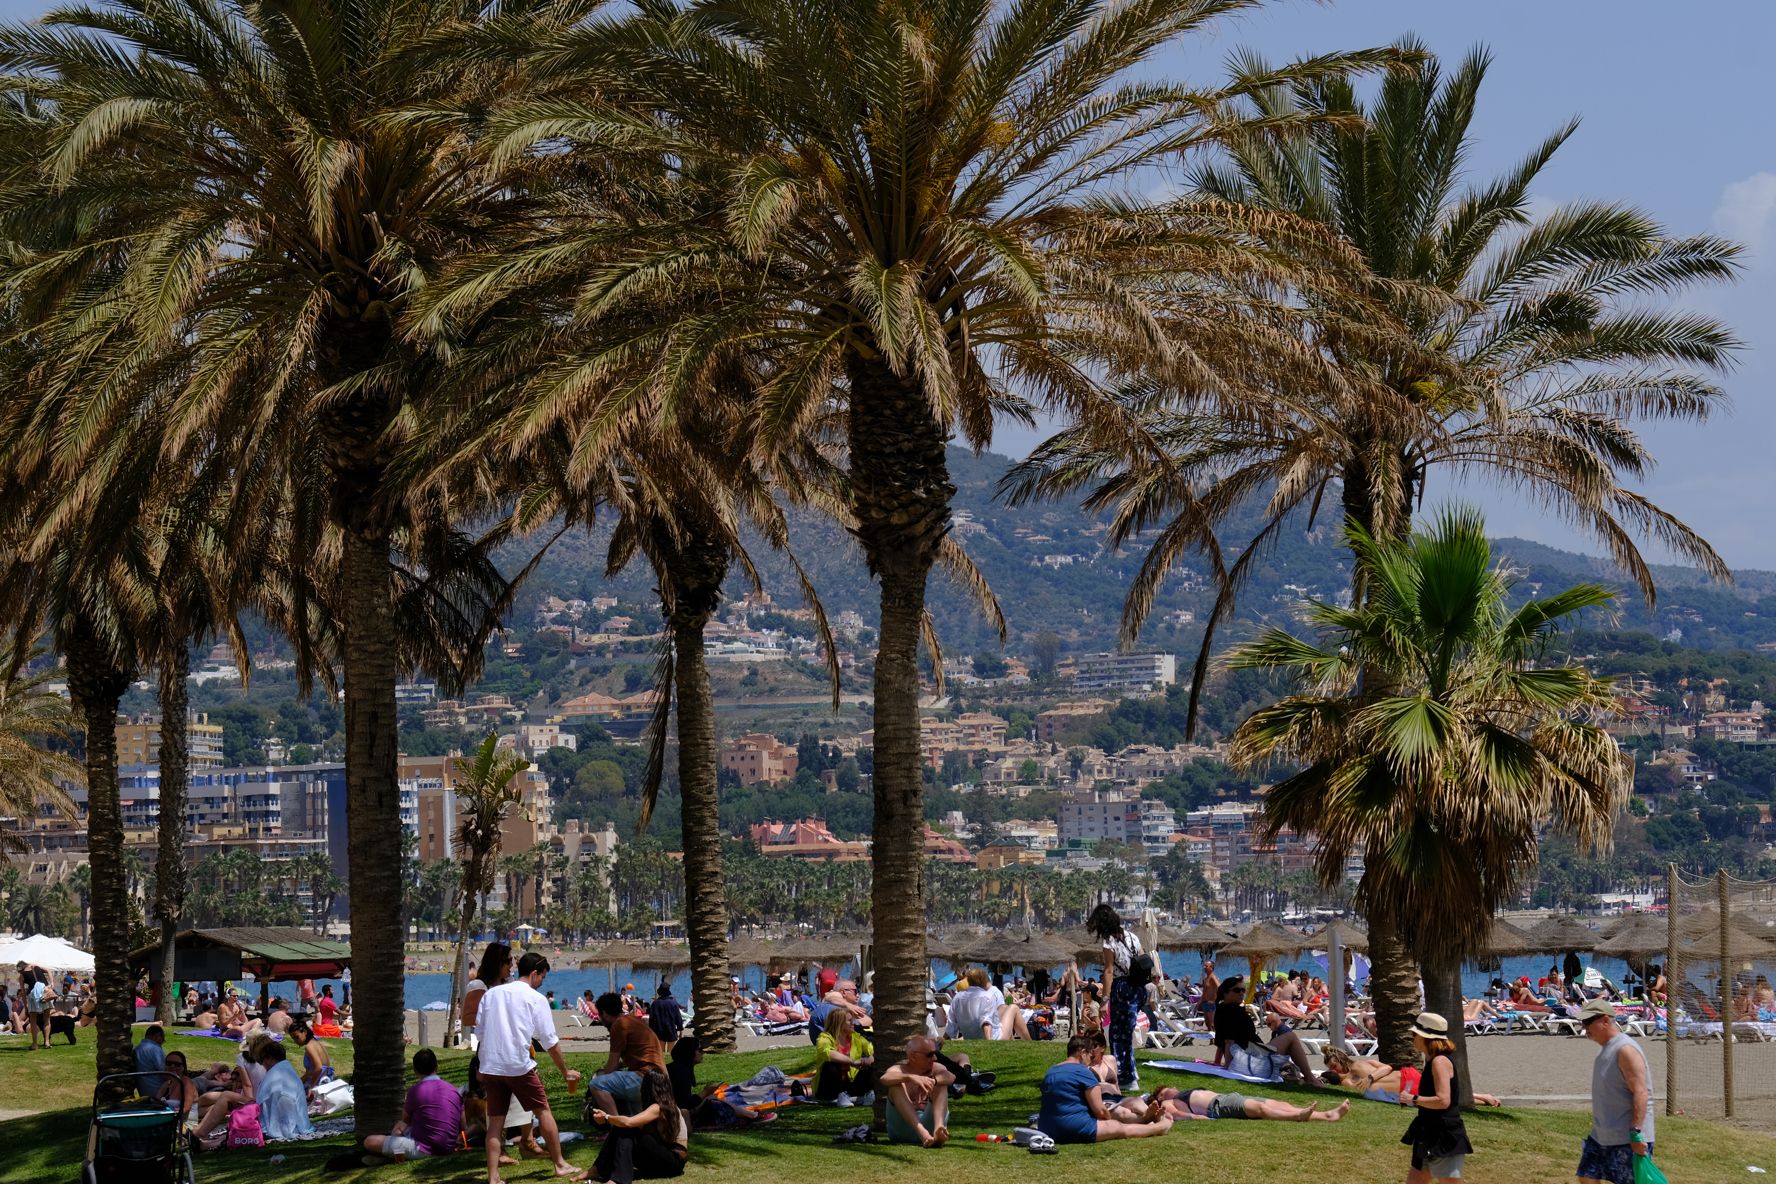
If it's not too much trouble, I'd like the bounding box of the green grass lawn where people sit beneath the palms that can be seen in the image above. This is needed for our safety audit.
[0,1033,1776,1184]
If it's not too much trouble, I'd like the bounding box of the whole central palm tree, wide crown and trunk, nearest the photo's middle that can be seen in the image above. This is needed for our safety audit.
[475,0,1380,1046]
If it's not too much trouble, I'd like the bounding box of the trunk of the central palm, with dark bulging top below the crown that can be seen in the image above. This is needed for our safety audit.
[845,355,955,1049]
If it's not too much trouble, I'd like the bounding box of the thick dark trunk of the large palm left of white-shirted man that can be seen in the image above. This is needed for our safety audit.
[343,531,407,1133]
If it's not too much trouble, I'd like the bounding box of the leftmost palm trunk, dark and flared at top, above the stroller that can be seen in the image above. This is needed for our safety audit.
[66,621,135,1100]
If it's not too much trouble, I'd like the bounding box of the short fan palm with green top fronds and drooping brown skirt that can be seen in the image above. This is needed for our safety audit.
[1224,511,1632,1088]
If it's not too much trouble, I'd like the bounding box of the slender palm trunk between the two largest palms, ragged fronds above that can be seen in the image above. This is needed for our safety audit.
[664,522,733,1053]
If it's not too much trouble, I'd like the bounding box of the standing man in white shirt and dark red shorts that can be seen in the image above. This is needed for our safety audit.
[474,953,590,1184]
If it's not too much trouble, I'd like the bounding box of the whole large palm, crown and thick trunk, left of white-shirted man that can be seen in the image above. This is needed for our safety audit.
[0,0,590,1129]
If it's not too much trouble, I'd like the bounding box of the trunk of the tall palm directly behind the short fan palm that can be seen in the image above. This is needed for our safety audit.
[1344,453,1413,1065]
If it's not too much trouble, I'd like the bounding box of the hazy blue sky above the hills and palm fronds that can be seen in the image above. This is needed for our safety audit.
[0,0,1776,568]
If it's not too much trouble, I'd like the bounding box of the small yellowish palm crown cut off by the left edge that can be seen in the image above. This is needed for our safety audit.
[0,641,85,852]
